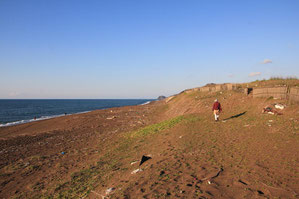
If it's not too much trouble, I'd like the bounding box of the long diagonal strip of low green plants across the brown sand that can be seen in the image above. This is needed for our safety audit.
[38,115,199,198]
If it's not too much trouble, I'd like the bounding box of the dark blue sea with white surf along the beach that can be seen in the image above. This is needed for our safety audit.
[0,99,153,127]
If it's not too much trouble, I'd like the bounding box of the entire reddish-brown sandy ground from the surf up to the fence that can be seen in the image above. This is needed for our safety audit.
[0,84,299,198]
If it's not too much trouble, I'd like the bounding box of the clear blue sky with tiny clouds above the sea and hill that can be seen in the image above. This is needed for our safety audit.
[0,0,299,99]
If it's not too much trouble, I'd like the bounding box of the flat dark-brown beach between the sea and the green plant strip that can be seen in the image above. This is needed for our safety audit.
[0,101,160,198]
